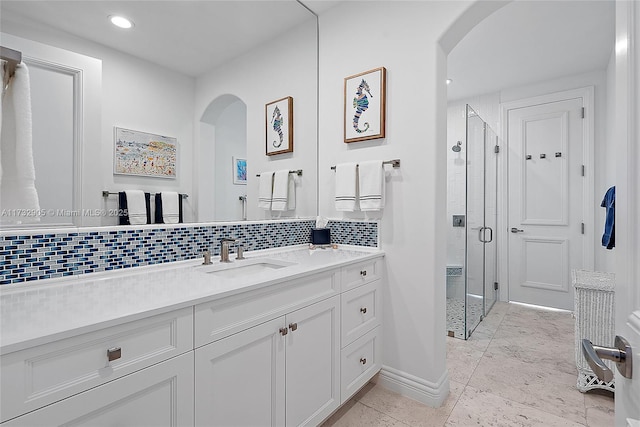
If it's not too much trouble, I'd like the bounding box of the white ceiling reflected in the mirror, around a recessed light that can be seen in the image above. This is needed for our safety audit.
[0,0,318,77]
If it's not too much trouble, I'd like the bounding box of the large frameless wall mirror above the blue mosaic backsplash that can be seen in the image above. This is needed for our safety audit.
[0,0,318,228]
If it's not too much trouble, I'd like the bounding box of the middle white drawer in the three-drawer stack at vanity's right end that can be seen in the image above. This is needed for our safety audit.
[341,280,382,347]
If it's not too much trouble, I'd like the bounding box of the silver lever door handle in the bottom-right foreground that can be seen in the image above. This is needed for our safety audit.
[582,335,633,382]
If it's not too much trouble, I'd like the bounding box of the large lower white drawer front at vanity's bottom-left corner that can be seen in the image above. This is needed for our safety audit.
[3,352,193,427]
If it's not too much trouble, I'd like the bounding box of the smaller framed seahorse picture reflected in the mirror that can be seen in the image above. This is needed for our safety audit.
[265,96,293,156]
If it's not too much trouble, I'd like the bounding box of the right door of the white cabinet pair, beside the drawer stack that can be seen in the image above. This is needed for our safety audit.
[286,296,340,427]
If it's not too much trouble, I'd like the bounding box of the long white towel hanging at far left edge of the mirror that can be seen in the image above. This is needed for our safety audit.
[0,64,40,223]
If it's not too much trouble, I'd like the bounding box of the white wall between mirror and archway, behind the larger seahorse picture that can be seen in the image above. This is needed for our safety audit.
[318,2,468,405]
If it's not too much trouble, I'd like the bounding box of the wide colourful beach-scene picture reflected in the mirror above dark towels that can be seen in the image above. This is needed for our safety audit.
[113,127,178,178]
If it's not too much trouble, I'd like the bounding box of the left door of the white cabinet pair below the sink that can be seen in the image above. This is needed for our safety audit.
[195,317,287,427]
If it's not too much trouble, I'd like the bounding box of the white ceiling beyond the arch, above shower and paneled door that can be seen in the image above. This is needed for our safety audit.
[447,0,615,100]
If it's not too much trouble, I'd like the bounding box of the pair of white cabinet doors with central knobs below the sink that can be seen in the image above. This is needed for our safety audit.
[195,296,340,426]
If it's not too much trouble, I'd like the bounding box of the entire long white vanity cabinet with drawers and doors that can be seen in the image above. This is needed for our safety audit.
[0,252,383,427]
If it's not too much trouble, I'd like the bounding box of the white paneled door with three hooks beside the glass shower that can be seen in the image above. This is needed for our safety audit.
[507,97,584,310]
